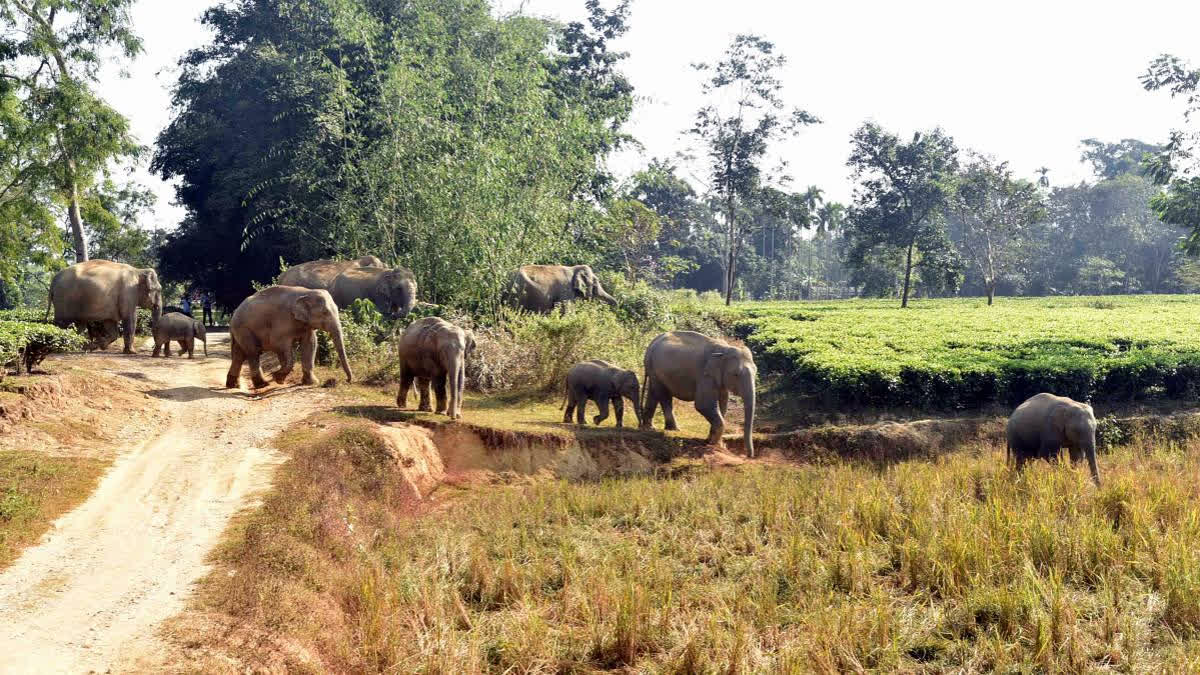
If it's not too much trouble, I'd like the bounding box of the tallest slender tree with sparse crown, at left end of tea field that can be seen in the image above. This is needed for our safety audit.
[691,35,821,305]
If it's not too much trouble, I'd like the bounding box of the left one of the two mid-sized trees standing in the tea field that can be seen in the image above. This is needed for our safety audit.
[846,123,958,307]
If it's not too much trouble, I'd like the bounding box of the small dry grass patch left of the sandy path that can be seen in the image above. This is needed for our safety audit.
[0,452,108,569]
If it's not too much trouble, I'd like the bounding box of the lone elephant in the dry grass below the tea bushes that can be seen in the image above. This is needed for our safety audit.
[1006,393,1100,485]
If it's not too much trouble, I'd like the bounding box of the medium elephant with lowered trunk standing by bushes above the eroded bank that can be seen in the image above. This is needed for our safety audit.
[396,316,475,419]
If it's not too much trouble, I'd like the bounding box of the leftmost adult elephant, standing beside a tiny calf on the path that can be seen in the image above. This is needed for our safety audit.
[46,259,162,354]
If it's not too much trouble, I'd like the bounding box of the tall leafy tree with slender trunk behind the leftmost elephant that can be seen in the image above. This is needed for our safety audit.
[0,0,142,261]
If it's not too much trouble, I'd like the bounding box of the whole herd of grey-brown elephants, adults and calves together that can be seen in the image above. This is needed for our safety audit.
[47,256,1100,473]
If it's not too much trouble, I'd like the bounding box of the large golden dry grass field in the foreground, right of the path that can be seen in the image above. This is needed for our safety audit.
[184,413,1200,673]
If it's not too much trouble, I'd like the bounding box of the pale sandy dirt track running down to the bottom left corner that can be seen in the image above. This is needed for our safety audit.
[0,334,330,673]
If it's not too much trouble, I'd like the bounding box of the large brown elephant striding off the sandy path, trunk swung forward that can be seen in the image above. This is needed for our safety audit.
[226,286,354,389]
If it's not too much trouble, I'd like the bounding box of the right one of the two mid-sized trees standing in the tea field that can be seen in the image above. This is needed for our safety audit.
[950,154,1045,305]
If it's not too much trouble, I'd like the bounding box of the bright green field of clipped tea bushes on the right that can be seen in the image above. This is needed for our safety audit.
[736,295,1200,410]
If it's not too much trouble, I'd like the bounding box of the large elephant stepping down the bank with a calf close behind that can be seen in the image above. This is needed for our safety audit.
[641,330,757,458]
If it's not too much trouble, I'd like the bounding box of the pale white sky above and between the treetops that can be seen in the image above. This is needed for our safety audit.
[102,0,1200,228]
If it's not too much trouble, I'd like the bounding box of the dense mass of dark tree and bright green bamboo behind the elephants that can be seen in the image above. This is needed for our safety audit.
[154,0,631,313]
